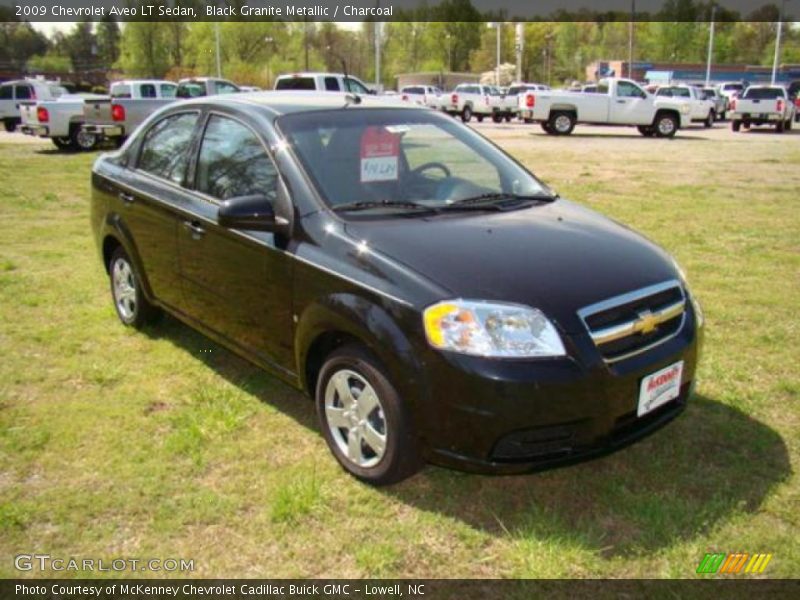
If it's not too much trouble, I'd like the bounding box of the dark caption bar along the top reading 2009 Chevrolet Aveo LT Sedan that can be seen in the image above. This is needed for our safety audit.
[0,0,798,22]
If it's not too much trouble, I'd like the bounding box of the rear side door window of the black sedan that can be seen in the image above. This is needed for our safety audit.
[138,113,198,184]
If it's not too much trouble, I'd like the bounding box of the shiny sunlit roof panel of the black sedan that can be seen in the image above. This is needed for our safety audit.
[173,90,412,116]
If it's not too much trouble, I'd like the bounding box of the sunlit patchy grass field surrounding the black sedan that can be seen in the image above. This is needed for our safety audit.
[0,126,800,577]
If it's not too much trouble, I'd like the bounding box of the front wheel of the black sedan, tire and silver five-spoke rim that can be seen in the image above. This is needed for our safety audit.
[316,345,422,485]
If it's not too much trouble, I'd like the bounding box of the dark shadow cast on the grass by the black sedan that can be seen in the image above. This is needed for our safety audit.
[142,317,791,557]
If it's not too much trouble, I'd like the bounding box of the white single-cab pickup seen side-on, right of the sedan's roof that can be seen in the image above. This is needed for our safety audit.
[519,77,691,137]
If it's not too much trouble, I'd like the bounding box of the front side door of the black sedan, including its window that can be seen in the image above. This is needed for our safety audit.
[178,112,292,370]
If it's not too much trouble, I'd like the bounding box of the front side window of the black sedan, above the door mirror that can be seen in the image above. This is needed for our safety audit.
[197,116,278,202]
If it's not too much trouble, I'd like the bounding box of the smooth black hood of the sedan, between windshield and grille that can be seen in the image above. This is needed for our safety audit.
[346,199,678,332]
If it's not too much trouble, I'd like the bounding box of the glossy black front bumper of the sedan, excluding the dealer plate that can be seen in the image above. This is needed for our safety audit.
[420,304,702,474]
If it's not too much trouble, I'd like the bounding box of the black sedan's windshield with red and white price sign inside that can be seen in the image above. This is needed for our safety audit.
[277,107,552,212]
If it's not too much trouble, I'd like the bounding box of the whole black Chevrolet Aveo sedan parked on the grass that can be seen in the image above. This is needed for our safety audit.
[92,93,702,484]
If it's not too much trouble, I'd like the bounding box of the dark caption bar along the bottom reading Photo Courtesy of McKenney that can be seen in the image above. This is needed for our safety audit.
[0,578,800,600]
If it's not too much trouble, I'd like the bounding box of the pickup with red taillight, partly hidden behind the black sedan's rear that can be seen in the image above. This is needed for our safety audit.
[82,79,178,146]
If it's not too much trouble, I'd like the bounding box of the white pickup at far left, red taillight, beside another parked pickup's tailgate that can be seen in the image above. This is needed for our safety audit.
[19,94,103,150]
